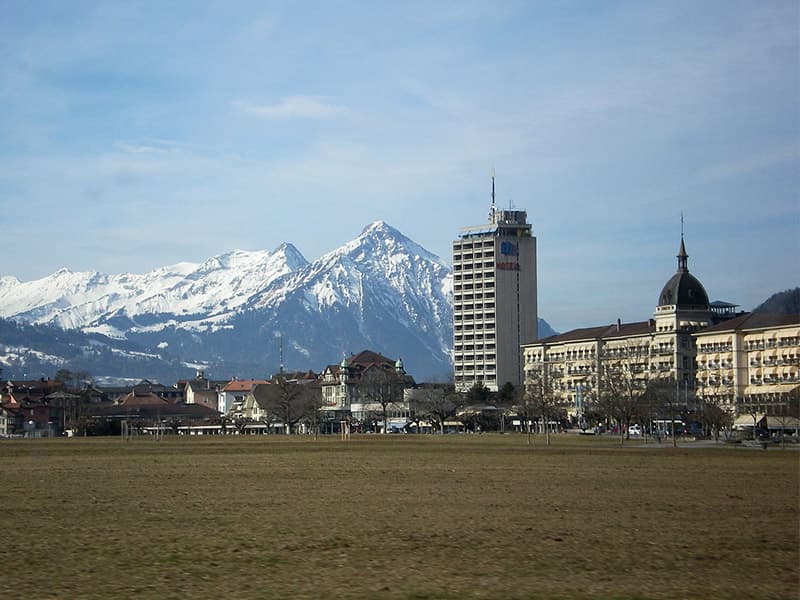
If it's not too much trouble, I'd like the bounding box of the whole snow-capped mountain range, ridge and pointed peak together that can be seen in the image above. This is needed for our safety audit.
[0,221,452,378]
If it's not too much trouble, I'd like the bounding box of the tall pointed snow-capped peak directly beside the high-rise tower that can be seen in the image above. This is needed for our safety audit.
[234,221,452,377]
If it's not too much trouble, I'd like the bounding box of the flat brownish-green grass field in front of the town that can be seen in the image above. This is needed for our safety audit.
[0,435,800,599]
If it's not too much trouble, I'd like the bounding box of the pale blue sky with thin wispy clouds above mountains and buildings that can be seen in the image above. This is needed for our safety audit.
[0,0,800,331]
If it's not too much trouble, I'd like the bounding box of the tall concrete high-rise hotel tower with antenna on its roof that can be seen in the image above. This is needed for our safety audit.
[453,175,538,391]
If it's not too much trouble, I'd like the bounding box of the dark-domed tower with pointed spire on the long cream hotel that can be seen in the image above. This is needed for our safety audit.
[652,232,712,390]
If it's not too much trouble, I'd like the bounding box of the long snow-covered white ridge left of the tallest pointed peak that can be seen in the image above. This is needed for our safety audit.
[0,244,308,337]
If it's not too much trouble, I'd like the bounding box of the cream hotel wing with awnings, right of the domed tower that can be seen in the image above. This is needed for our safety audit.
[695,313,800,416]
